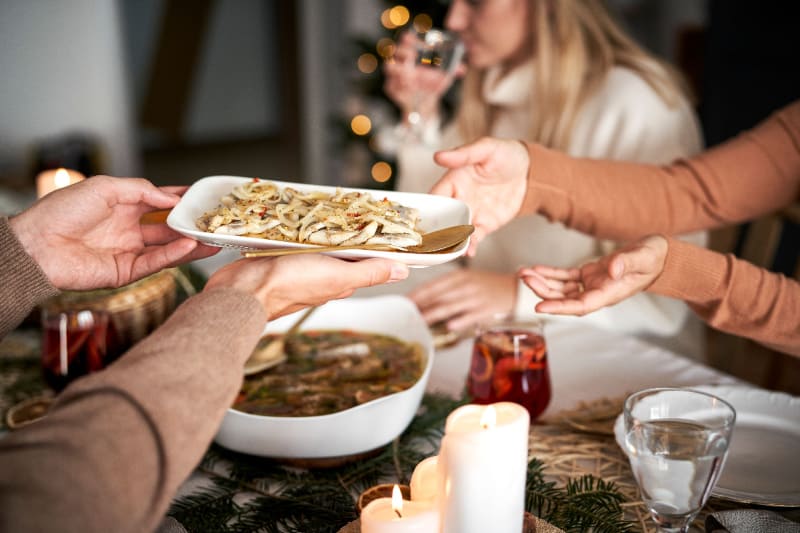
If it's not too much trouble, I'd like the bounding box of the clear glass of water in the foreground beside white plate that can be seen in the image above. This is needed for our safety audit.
[623,389,736,531]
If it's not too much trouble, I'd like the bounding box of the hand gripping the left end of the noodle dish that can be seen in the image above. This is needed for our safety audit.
[9,176,218,290]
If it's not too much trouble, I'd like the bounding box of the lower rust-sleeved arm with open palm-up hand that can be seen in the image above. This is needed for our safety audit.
[520,236,800,355]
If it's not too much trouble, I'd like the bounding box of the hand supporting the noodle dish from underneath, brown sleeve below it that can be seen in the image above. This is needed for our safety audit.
[204,254,408,320]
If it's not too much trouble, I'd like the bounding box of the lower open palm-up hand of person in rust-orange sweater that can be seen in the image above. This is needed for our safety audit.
[519,235,668,316]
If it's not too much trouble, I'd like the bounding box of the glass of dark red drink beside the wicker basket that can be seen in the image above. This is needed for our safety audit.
[42,309,118,391]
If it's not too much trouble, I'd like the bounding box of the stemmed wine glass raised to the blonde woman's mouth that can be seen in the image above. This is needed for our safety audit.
[406,28,464,140]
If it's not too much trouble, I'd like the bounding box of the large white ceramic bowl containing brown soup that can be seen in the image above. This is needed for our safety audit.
[215,295,433,459]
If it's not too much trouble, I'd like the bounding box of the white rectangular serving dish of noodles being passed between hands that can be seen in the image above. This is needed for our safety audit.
[167,176,470,267]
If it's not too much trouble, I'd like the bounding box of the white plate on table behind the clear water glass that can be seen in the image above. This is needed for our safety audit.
[614,385,800,507]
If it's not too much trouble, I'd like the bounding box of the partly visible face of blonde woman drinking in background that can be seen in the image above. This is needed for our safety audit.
[444,0,532,68]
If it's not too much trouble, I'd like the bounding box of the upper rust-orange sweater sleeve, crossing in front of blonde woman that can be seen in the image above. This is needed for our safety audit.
[520,101,800,240]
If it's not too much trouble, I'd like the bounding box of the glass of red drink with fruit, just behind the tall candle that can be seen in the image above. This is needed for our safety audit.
[467,320,551,420]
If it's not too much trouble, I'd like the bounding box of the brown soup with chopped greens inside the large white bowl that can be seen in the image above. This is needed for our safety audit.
[233,330,425,416]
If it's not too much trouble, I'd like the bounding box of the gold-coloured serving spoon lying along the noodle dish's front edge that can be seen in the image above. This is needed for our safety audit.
[242,224,475,257]
